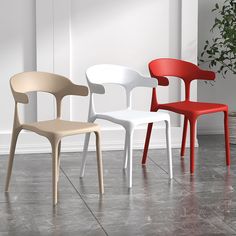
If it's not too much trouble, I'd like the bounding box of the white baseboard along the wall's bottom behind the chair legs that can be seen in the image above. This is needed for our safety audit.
[0,126,195,154]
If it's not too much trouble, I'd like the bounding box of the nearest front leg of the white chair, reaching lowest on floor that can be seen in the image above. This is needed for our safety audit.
[126,130,134,188]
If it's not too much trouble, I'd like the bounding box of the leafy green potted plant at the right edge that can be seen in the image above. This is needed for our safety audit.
[199,0,236,144]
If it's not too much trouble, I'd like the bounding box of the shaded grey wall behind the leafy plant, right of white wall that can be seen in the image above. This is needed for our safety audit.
[198,0,236,134]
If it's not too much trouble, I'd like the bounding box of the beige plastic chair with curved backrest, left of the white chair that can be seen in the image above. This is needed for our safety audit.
[5,72,104,205]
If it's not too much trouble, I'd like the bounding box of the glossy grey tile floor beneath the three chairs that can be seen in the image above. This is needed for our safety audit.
[0,136,236,236]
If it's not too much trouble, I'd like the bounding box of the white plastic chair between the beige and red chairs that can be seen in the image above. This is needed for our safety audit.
[80,65,172,188]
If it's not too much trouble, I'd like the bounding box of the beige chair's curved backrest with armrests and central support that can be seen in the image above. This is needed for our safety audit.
[10,71,88,117]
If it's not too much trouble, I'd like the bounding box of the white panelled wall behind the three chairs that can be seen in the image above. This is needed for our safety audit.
[0,0,197,153]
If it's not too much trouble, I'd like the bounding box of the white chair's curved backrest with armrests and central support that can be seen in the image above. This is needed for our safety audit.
[86,64,158,113]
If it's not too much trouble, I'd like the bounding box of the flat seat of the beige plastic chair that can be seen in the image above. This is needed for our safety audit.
[22,119,100,137]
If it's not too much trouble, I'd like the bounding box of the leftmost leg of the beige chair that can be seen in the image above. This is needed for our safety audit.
[5,129,20,192]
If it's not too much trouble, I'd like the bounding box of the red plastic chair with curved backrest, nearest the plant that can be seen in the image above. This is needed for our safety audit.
[142,58,230,174]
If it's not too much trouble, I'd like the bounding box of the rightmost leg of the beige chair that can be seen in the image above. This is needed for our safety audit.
[95,132,104,194]
